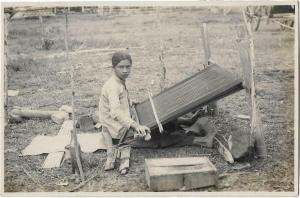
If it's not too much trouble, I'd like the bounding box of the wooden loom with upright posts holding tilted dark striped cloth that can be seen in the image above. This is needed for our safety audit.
[136,16,267,159]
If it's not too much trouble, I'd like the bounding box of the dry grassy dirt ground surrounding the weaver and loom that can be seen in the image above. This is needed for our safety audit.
[4,8,295,192]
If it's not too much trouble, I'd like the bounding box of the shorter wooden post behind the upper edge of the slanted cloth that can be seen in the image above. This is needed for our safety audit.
[200,23,218,116]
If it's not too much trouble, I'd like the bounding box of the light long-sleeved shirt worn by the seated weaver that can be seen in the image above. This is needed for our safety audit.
[99,74,135,139]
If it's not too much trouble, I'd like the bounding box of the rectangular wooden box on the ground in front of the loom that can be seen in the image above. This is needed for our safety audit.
[145,157,218,191]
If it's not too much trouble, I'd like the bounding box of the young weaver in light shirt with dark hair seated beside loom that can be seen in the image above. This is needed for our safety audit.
[99,52,150,170]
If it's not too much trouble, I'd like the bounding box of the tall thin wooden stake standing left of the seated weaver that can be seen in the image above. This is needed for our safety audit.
[65,12,85,181]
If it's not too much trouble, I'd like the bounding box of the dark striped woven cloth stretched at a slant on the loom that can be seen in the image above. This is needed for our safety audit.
[136,64,243,129]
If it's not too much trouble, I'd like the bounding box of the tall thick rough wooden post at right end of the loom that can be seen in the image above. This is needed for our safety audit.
[237,9,267,158]
